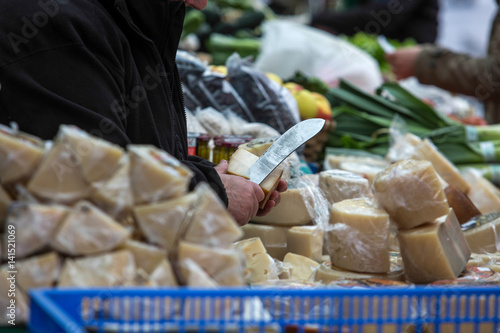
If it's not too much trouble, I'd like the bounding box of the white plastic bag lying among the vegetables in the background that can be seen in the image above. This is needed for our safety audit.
[255,19,383,92]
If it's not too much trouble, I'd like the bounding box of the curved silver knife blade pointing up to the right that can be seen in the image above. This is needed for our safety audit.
[249,118,326,185]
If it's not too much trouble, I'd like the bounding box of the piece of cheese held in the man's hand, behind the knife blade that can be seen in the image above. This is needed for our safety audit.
[227,148,283,208]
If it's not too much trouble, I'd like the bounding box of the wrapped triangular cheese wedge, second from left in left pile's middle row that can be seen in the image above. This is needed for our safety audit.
[51,201,130,256]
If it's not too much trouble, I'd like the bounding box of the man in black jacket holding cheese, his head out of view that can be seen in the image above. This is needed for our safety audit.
[0,0,286,224]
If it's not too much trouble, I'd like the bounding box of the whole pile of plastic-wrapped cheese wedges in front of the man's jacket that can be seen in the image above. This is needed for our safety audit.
[0,126,245,323]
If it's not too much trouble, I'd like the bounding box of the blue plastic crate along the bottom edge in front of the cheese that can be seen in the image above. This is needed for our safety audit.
[29,286,500,333]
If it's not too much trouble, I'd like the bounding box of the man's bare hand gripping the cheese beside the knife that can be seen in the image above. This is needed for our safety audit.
[215,160,288,225]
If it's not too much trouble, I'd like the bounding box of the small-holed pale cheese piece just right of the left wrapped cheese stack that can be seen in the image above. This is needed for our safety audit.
[235,237,278,283]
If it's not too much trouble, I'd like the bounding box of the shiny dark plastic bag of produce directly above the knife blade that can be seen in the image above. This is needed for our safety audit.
[226,53,300,134]
